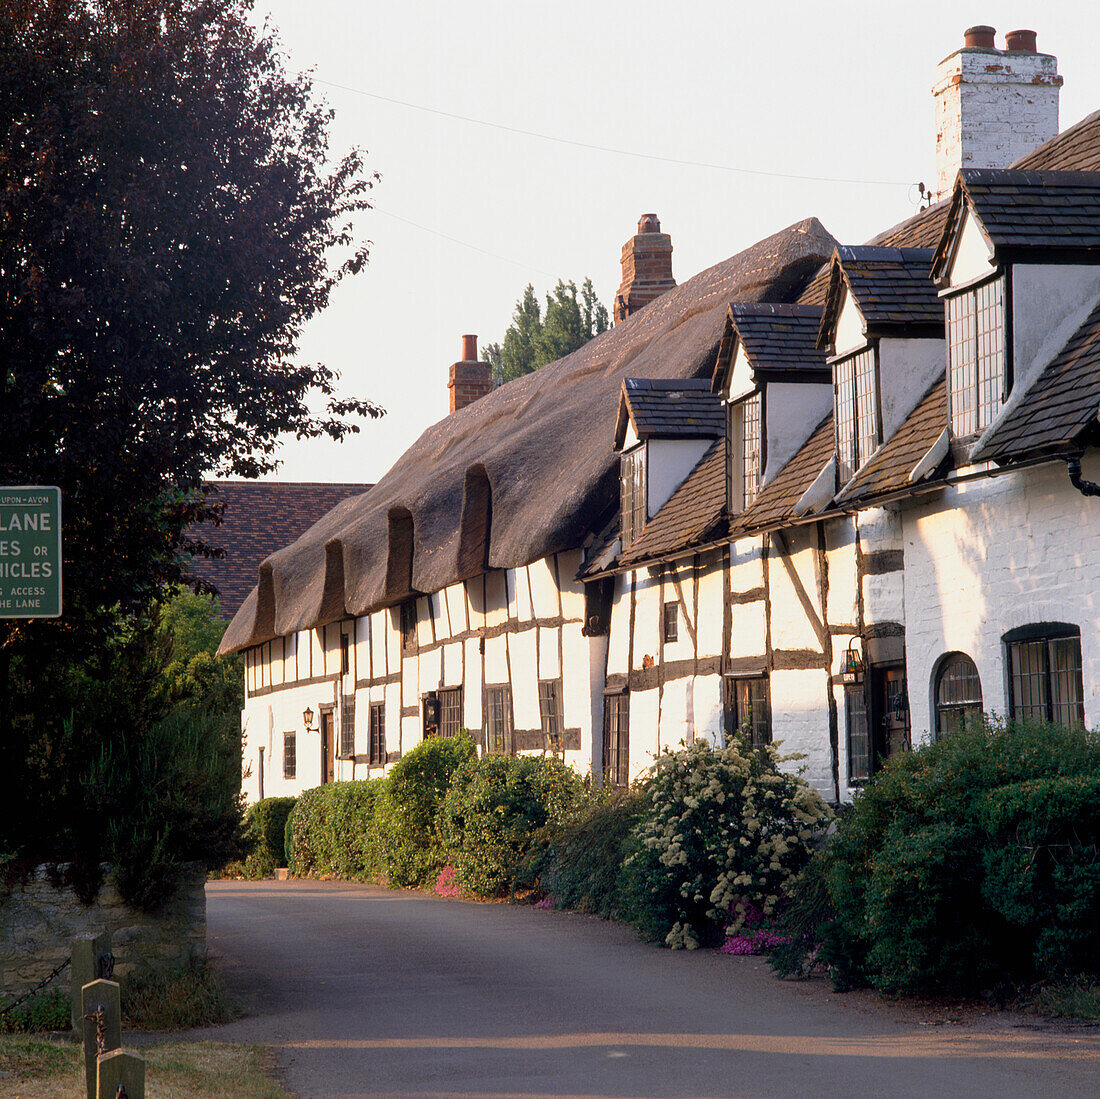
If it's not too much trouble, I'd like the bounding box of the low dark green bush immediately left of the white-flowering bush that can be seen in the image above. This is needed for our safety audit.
[531,791,649,920]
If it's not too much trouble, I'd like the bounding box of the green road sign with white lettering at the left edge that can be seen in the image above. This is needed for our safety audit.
[0,485,62,618]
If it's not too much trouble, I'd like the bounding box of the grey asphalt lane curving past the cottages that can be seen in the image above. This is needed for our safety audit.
[207,881,1100,1099]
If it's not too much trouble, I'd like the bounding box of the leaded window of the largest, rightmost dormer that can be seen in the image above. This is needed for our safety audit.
[946,276,1007,438]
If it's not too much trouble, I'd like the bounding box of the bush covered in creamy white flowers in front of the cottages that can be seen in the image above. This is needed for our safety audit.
[625,737,833,949]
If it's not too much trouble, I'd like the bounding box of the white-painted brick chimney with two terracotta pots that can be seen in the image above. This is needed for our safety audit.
[932,26,1062,198]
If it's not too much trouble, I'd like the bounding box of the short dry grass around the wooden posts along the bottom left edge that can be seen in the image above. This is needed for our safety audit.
[0,1036,290,1099]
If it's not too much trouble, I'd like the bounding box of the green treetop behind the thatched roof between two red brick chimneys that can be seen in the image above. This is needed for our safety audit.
[484,278,608,385]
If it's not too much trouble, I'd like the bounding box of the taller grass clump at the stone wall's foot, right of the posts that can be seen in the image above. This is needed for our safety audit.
[122,955,243,1031]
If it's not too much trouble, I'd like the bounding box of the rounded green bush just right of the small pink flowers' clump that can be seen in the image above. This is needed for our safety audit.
[442,756,584,897]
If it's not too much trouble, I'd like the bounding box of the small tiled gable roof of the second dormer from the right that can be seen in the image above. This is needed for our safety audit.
[821,244,944,347]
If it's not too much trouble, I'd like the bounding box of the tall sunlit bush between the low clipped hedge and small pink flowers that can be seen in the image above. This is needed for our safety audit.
[375,735,476,886]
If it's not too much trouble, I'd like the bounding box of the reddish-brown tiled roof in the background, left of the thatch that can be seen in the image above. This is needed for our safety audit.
[187,481,371,618]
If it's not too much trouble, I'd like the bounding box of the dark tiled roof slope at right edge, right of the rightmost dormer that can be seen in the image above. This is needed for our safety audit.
[972,305,1100,461]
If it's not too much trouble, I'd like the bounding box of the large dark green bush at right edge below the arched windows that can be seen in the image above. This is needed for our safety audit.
[777,719,1100,994]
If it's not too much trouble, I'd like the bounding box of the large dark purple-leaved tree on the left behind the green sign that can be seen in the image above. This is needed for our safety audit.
[0,0,381,875]
